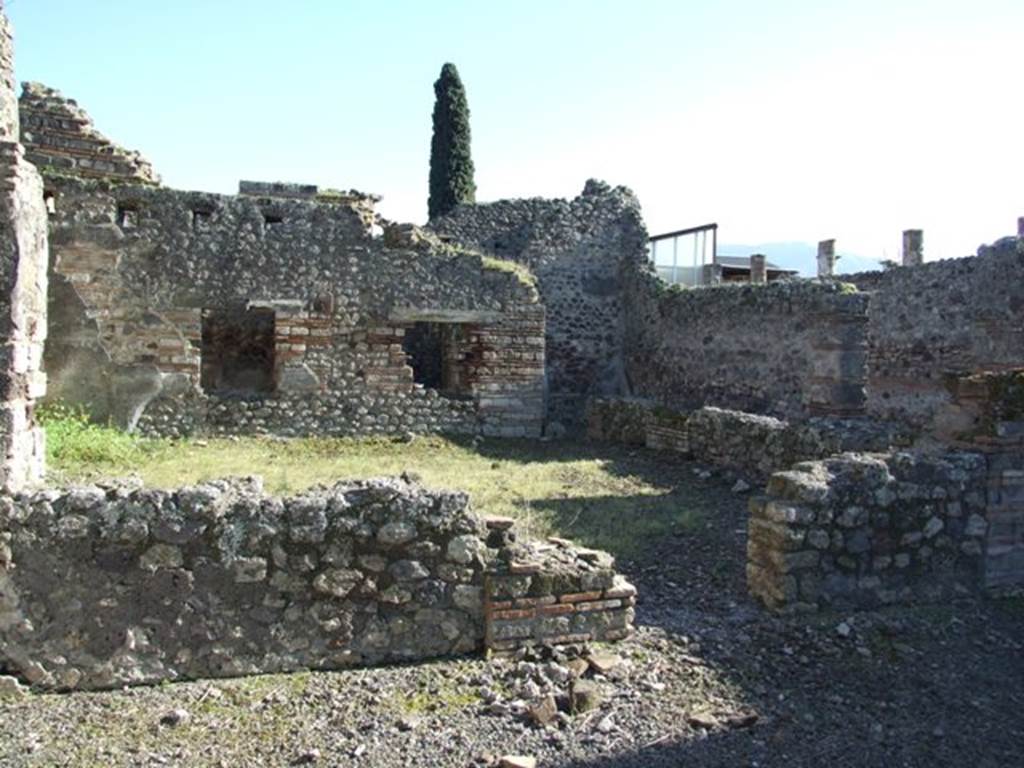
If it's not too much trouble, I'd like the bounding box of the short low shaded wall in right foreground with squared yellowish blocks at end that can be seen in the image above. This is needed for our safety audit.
[746,453,988,610]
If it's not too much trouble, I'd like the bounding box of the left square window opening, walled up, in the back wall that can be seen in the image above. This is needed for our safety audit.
[200,307,274,395]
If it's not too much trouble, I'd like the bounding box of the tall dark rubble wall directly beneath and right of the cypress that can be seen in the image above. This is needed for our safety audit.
[431,180,647,423]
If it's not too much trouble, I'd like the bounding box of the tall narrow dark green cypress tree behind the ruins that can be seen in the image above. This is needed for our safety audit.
[427,63,476,219]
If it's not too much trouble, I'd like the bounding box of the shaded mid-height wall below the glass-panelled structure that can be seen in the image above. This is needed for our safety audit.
[625,278,867,418]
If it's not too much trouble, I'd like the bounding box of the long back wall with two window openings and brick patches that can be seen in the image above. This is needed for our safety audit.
[46,176,545,436]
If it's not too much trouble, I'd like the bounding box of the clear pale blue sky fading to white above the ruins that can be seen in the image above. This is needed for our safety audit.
[7,0,1024,258]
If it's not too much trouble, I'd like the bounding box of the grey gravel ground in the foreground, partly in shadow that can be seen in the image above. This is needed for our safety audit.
[0,462,1024,768]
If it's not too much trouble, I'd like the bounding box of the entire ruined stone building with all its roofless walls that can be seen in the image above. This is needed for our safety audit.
[0,0,1024,688]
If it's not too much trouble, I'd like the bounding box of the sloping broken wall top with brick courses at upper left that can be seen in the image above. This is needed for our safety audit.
[20,83,160,184]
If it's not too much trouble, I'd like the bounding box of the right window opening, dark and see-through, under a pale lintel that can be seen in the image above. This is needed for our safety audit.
[402,323,471,397]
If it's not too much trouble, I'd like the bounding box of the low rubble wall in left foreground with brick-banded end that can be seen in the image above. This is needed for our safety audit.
[0,478,633,690]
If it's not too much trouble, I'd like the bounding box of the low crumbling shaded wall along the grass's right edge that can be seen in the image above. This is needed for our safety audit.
[587,398,909,478]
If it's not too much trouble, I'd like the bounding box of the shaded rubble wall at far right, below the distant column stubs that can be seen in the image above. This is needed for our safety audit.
[843,238,1024,430]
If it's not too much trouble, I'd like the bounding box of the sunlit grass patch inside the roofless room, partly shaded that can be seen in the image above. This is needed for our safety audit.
[44,428,720,556]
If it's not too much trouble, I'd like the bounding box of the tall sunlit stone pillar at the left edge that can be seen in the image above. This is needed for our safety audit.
[0,2,47,490]
